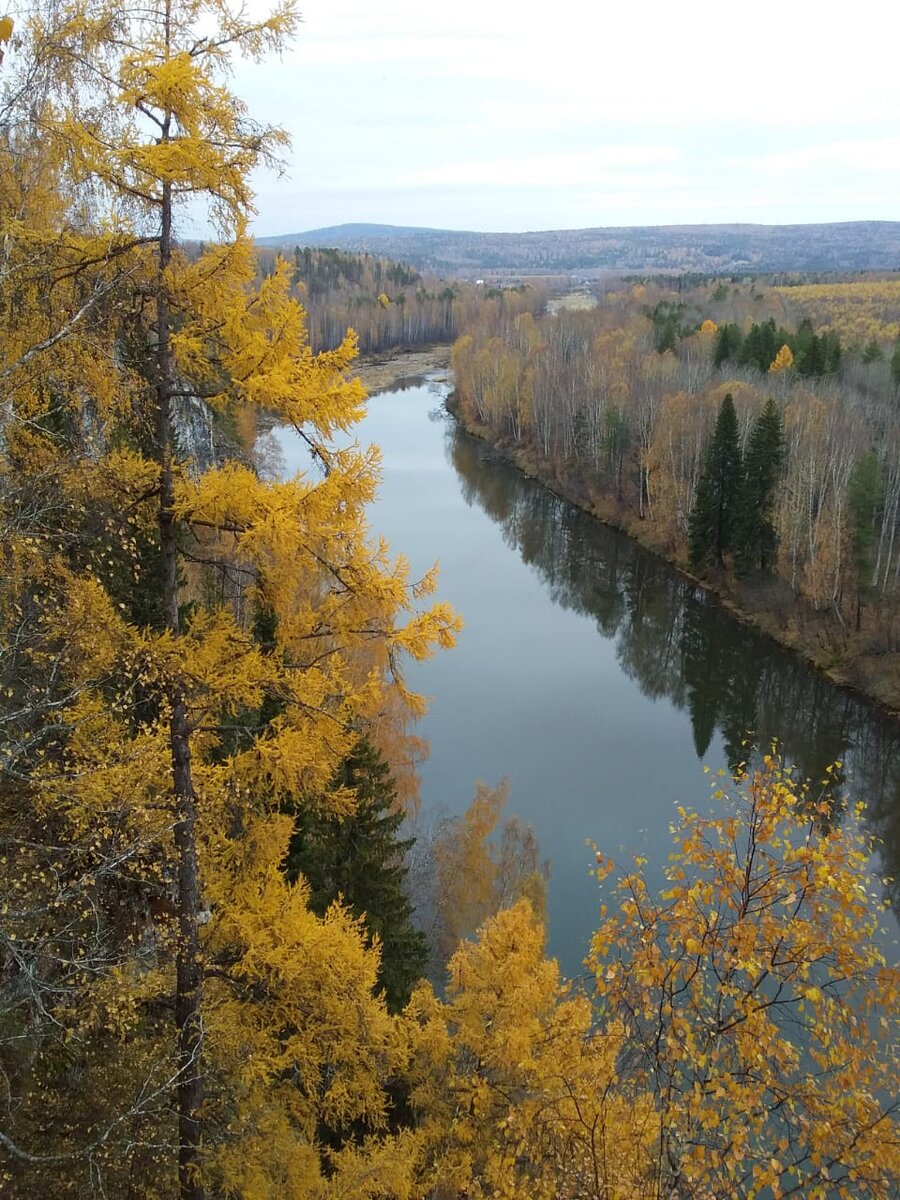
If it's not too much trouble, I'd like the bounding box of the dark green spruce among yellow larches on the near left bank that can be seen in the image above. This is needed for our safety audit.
[286,738,428,1012]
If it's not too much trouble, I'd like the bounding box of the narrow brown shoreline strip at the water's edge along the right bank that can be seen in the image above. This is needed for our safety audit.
[445,392,900,721]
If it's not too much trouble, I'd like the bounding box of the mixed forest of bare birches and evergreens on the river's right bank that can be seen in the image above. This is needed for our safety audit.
[452,277,900,709]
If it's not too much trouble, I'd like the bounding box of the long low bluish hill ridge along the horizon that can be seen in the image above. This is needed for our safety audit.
[257,221,900,276]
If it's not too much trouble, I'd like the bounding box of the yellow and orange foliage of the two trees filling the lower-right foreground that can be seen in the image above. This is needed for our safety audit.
[407,755,900,1200]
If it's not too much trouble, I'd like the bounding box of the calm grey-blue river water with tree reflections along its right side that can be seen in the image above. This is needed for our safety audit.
[282,380,900,976]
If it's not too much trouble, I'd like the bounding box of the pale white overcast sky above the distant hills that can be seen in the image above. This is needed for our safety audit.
[234,0,900,235]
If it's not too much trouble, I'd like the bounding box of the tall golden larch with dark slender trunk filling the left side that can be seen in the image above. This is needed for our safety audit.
[0,0,456,1200]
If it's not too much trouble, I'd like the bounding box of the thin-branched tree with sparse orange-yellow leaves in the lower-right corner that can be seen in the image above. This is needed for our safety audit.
[589,756,900,1200]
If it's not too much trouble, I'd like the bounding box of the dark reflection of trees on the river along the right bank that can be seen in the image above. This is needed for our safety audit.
[446,424,900,911]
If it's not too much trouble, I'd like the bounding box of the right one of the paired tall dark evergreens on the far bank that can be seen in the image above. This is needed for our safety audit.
[734,397,786,572]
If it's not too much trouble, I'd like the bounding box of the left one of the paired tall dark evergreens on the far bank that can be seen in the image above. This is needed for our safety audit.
[688,392,743,566]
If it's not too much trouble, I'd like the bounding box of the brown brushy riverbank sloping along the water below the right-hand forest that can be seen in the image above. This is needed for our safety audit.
[446,396,900,719]
